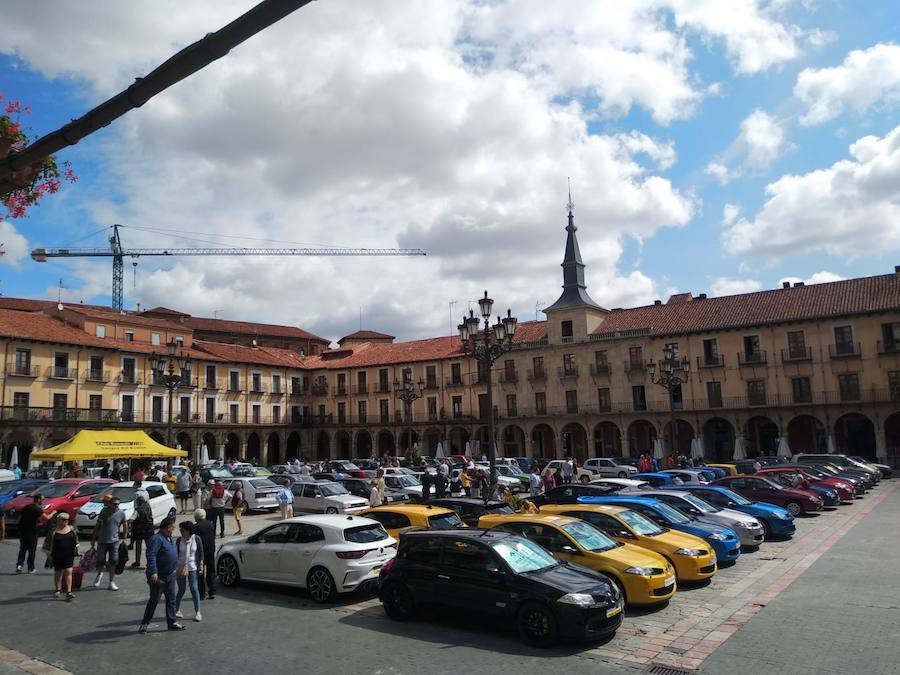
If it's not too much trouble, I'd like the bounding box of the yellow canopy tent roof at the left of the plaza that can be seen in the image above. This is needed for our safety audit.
[28,429,188,462]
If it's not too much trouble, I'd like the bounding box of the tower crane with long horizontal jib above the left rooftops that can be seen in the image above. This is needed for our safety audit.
[31,225,425,311]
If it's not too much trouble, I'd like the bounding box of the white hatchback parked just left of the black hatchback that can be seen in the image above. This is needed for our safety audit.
[216,515,397,602]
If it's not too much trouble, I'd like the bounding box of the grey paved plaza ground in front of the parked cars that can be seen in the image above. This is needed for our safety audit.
[0,481,900,675]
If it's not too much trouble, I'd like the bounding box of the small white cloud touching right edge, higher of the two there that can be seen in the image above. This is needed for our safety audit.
[794,44,900,126]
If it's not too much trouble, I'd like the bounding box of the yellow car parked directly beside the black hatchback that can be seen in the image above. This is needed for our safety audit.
[478,513,676,605]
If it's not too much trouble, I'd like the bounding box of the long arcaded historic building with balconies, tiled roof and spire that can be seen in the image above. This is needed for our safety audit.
[0,213,900,464]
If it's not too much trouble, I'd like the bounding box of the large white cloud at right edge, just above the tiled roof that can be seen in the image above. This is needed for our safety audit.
[724,127,900,256]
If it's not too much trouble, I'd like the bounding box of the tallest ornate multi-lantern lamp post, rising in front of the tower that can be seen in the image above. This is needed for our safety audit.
[457,291,518,485]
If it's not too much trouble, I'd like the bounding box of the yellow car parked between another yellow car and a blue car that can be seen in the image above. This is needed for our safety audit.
[541,504,718,582]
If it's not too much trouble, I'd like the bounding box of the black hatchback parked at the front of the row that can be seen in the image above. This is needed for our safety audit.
[378,529,624,647]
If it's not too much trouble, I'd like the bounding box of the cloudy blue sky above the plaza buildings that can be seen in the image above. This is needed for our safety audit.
[0,0,900,339]
